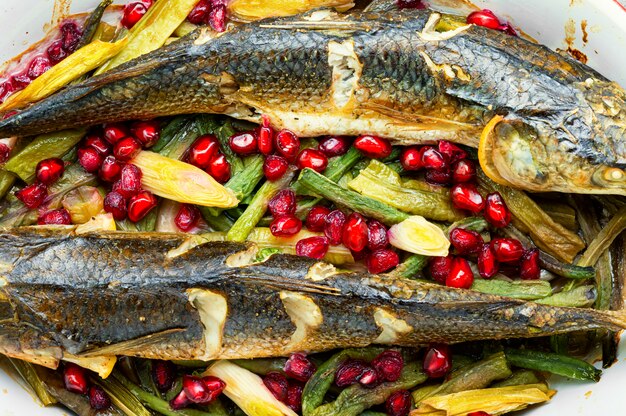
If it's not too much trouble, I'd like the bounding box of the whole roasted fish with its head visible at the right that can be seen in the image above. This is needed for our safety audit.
[0,10,626,194]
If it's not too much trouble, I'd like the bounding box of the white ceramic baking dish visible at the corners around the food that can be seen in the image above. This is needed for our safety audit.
[0,0,626,416]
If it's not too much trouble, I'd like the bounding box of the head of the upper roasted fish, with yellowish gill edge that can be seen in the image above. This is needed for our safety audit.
[478,79,626,195]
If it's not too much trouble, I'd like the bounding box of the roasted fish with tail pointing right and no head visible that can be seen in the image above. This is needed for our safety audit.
[0,228,626,367]
